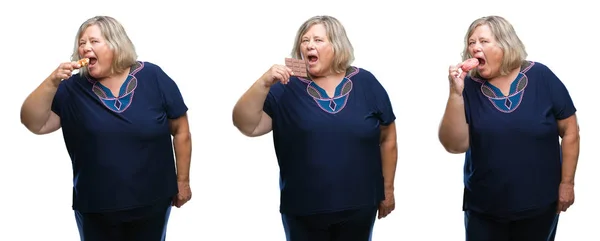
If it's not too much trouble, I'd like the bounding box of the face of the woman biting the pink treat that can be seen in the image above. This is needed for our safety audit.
[467,24,504,79]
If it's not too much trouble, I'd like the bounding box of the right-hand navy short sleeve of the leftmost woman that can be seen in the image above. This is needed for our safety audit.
[157,66,188,119]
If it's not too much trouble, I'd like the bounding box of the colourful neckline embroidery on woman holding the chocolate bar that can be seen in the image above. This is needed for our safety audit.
[299,67,359,114]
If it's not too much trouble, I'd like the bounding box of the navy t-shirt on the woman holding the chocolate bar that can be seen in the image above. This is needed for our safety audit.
[264,67,396,215]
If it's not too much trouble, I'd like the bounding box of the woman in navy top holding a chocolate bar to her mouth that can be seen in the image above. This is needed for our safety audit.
[233,16,397,241]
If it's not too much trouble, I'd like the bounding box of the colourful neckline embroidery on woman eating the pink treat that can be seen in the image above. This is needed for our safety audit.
[471,62,534,113]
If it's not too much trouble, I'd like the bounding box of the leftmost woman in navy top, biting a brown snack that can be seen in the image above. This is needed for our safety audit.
[21,16,191,241]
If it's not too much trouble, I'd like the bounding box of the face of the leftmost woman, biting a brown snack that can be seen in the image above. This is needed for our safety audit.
[79,25,114,79]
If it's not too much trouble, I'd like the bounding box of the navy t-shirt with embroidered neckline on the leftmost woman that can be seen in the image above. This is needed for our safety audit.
[52,62,188,212]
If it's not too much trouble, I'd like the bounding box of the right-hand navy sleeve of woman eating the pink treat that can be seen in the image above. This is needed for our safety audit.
[542,66,577,120]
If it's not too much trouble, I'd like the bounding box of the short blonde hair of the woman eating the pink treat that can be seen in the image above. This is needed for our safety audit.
[462,16,527,77]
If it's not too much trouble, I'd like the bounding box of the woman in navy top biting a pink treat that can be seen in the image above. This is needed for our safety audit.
[439,16,579,241]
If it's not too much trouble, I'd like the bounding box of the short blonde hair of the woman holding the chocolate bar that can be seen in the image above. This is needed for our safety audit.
[292,15,354,73]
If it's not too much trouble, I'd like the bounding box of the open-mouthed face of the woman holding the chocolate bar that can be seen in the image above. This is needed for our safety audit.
[300,24,334,77]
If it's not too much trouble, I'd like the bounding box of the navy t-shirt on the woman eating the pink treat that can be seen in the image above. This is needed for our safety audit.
[463,61,576,219]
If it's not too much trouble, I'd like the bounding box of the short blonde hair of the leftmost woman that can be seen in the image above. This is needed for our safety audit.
[71,16,138,76]
